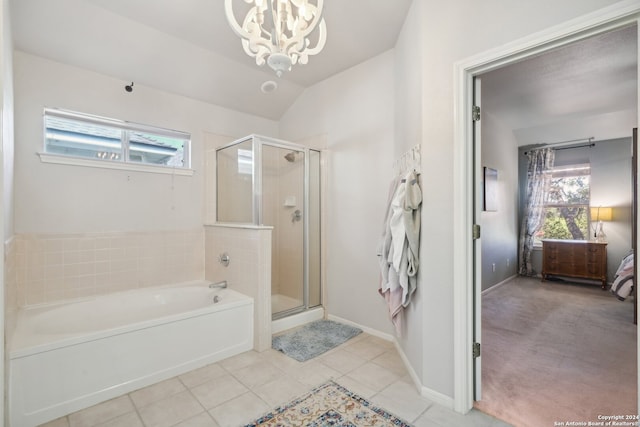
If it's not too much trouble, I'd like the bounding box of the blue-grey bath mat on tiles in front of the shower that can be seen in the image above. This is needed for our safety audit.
[271,320,362,362]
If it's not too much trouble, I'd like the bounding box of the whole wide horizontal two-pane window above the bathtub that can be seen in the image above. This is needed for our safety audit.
[40,109,191,173]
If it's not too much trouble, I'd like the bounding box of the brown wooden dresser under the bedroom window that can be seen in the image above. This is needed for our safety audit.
[542,240,607,289]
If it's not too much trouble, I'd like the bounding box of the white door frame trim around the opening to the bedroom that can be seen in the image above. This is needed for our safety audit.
[454,6,640,413]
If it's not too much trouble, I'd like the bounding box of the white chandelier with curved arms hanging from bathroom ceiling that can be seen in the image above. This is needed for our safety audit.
[224,0,327,77]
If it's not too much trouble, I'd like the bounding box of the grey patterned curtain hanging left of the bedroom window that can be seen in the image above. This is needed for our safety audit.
[518,148,555,276]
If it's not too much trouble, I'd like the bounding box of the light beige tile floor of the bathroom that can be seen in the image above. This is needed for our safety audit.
[44,333,509,427]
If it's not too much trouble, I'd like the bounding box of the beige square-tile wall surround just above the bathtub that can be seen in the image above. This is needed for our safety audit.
[11,229,204,307]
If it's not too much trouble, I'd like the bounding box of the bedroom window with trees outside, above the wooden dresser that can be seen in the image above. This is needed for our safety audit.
[536,164,591,244]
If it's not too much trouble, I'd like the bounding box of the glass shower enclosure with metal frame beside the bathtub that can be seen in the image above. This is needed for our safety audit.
[216,135,322,319]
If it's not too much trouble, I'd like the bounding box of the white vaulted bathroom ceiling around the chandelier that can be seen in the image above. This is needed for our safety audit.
[11,0,411,120]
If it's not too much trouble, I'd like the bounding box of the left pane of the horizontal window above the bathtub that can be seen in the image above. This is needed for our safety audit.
[45,116,122,160]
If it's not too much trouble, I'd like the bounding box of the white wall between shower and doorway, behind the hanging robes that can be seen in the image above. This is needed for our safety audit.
[280,0,615,397]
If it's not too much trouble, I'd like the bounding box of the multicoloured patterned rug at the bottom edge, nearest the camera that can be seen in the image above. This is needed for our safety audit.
[245,381,411,427]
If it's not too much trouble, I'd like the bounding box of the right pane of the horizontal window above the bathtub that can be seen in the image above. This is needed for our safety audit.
[129,132,187,167]
